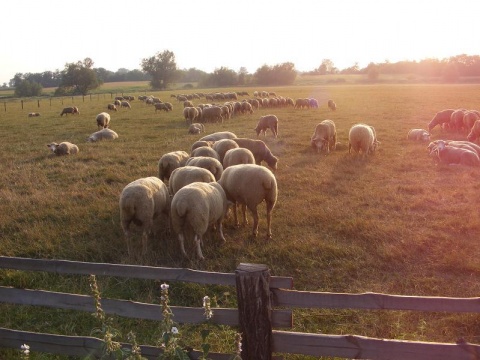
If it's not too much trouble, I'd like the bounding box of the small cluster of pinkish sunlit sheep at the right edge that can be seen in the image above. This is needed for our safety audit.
[407,109,480,166]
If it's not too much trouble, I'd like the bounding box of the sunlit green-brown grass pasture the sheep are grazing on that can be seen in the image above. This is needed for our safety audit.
[0,85,480,359]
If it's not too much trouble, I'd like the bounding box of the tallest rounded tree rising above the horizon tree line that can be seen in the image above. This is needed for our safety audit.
[140,50,177,89]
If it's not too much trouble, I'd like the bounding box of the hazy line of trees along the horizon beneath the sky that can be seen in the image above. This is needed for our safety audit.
[4,50,480,97]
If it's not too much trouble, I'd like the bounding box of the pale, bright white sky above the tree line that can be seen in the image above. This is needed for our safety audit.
[0,0,480,85]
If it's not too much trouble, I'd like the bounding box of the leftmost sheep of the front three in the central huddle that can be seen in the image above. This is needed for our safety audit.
[119,176,170,256]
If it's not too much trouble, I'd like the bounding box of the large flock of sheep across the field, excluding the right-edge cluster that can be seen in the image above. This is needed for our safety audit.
[43,92,378,260]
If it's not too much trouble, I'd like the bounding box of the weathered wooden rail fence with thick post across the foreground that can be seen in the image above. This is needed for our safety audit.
[0,257,480,360]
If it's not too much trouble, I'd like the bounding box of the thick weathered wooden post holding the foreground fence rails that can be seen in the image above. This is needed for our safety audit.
[235,263,272,360]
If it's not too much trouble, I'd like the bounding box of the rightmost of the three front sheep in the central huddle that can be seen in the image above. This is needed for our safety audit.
[218,164,278,239]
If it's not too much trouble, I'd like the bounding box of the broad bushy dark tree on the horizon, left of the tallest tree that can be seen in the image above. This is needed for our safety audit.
[60,58,101,95]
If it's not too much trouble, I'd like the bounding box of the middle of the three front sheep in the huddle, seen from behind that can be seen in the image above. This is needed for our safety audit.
[170,182,227,260]
